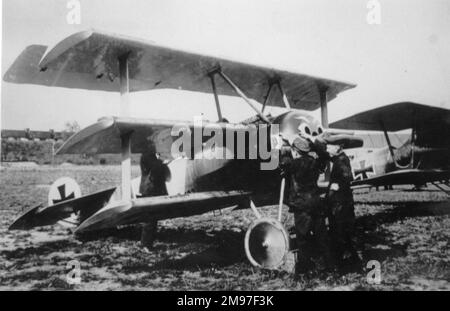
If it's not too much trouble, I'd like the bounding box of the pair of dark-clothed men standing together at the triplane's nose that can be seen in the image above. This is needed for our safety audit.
[280,136,359,274]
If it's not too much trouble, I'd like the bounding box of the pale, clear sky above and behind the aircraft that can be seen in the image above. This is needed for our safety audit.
[1,0,450,130]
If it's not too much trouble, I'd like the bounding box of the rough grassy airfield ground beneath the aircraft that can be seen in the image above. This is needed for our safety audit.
[0,166,450,290]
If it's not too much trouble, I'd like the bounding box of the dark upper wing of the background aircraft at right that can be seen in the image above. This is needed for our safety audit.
[330,102,450,132]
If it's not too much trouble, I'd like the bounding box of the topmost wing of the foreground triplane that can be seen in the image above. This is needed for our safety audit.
[4,30,355,110]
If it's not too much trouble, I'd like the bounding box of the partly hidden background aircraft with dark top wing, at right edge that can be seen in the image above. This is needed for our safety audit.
[331,102,450,193]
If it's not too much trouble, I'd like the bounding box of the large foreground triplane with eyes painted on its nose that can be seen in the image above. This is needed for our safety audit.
[4,30,362,268]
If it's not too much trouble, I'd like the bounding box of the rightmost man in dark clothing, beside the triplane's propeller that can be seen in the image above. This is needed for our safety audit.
[327,145,359,267]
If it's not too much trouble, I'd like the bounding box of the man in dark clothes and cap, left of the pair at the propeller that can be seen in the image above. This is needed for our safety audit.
[280,136,331,274]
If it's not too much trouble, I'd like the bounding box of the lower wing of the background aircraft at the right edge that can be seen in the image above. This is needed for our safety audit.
[352,169,450,186]
